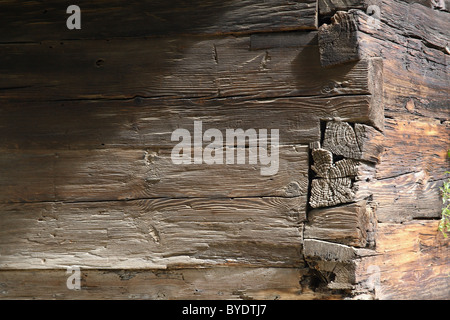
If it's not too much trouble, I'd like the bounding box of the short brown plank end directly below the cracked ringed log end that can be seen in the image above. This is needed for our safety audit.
[304,200,372,247]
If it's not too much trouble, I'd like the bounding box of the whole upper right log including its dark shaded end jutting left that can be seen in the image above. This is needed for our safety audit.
[319,10,450,120]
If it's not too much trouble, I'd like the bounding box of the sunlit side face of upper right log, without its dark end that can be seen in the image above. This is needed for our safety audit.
[358,13,450,120]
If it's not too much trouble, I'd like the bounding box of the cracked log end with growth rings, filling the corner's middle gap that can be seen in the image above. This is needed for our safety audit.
[309,121,384,208]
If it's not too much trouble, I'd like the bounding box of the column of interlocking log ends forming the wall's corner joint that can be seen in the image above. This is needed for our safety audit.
[303,3,384,299]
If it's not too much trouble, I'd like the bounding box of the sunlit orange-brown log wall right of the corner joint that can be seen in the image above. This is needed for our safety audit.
[312,0,450,299]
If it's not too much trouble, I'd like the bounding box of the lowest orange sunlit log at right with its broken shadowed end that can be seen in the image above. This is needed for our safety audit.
[304,220,449,300]
